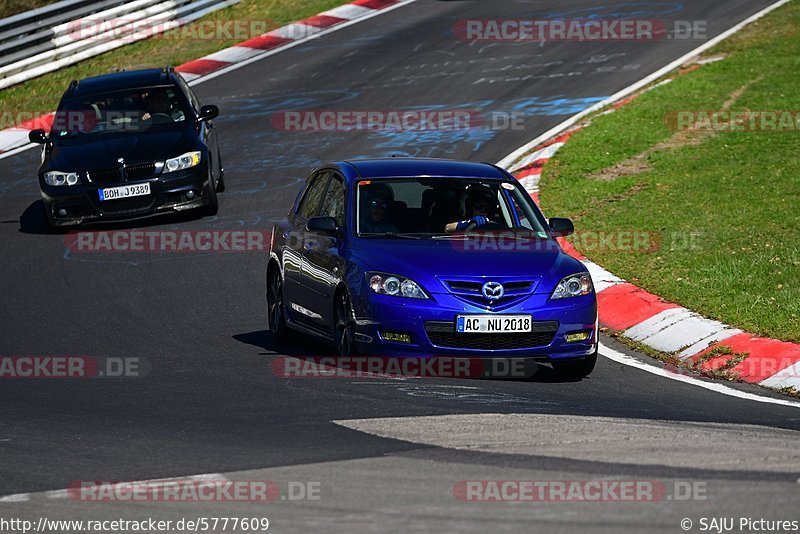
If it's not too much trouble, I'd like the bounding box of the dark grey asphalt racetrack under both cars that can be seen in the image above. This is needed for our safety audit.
[0,0,800,533]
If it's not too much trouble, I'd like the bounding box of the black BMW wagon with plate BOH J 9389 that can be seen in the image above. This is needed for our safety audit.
[30,67,225,227]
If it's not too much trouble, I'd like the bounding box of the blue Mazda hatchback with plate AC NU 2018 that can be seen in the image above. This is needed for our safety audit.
[266,158,598,377]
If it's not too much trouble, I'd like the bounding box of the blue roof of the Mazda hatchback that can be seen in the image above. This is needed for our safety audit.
[342,158,509,180]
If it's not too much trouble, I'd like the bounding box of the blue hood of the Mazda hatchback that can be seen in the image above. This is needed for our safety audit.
[351,238,586,293]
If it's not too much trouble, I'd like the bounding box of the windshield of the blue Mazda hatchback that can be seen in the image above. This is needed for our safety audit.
[356,178,548,238]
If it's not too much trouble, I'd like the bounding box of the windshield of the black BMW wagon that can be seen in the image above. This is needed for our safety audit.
[52,87,192,139]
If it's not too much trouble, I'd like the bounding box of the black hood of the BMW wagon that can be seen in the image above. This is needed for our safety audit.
[46,126,198,172]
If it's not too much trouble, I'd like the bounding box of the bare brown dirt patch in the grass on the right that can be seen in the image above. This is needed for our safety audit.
[587,78,761,181]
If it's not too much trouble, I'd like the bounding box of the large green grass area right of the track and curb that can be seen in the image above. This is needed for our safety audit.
[541,2,800,342]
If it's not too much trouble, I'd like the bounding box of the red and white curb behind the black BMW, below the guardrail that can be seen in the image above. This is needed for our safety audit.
[0,0,415,158]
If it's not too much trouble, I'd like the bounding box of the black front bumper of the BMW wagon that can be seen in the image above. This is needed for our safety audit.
[40,165,209,226]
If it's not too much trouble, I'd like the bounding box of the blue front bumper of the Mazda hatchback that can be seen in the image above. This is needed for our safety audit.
[355,294,598,361]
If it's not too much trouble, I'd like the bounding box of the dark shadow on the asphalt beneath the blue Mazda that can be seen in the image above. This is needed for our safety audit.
[232,330,581,383]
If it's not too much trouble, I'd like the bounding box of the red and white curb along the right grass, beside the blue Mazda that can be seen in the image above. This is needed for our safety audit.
[512,99,800,390]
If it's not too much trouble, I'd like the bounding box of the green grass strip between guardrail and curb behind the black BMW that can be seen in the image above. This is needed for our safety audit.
[0,0,346,128]
